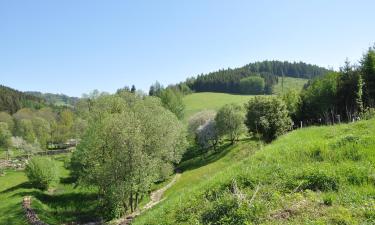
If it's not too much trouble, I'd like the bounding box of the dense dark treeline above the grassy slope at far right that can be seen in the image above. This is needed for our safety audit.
[283,48,375,124]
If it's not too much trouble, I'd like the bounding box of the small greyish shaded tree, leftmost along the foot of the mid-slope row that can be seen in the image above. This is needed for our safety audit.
[196,120,220,150]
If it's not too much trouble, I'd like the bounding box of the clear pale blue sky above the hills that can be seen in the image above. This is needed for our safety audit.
[0,0,375,96]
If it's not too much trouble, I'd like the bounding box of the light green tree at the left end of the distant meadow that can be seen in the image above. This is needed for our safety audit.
[160,88,185,119]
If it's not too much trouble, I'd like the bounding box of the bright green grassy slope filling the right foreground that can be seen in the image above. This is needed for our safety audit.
[134,120,375,224]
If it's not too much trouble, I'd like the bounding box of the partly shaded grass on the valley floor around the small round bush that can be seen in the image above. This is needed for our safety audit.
[0,154,98,225]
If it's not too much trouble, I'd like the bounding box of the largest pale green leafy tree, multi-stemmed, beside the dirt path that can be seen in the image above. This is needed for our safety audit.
[72,92,186,218]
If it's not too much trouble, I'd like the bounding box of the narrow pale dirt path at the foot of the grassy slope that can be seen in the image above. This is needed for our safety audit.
[114,173,181,225]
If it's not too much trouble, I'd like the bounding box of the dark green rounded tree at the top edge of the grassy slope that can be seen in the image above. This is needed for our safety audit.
[245,97,292,142]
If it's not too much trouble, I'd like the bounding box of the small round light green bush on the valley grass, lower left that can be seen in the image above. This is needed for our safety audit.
[25,157,57,190]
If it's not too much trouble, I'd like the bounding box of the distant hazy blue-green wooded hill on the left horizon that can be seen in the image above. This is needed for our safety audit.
[25,91,79,106]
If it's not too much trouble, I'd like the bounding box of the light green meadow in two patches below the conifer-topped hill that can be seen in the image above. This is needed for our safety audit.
[184,77,307,121]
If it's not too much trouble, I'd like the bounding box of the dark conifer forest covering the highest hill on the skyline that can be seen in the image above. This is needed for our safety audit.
[186,61,329,94]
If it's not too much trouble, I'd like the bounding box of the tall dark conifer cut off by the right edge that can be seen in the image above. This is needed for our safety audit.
[360,46,375,107]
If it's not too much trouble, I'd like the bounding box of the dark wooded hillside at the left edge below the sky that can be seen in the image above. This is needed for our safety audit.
[0,85,46,114]
